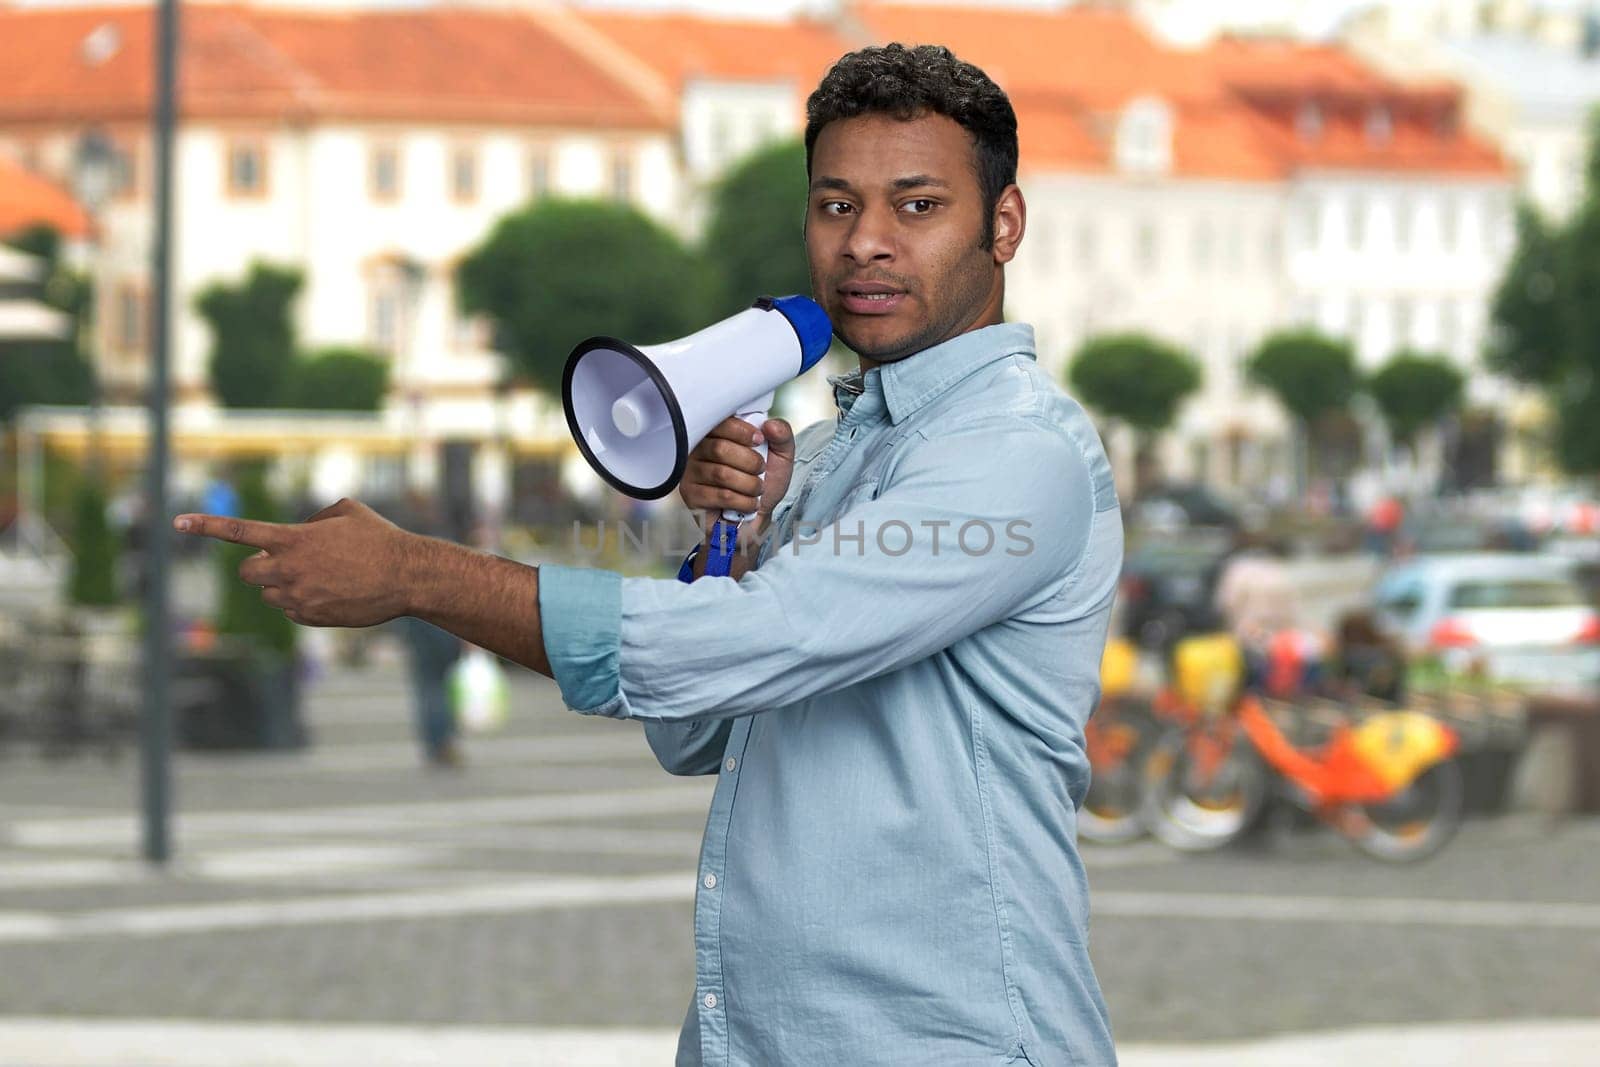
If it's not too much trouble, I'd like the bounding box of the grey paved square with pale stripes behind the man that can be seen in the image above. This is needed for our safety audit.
[0,646,1600,1064]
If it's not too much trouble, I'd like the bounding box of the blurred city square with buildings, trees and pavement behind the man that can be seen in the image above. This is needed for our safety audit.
[0,0,1600,1067]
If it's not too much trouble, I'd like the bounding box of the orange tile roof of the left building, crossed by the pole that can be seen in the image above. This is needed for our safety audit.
[0,5,675,128]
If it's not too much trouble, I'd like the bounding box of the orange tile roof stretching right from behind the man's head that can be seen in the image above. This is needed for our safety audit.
[856,0,1509,181]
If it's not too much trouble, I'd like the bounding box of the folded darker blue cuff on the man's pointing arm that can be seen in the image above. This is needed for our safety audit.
[539,565,622,715]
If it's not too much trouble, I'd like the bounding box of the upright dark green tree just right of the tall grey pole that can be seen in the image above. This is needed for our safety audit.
[195,262,304,408]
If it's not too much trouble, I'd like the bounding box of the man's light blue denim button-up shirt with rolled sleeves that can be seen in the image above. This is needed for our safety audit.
[539,325,1122,1067]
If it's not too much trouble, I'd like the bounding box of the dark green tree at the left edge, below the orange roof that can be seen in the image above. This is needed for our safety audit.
[0,226,94,421]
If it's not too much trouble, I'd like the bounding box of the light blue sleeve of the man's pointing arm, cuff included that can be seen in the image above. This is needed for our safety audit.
[541,414,1094,721]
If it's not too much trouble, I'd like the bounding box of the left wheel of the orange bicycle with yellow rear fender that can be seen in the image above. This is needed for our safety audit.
[1142,720,1270,853]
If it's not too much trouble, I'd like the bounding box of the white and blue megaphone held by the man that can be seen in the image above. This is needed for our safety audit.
[562,289,834,518]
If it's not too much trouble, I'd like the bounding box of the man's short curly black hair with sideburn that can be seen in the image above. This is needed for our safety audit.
[805,45,1018,248]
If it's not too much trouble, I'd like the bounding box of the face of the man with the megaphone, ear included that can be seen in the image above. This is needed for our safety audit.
[805,115,1021,363]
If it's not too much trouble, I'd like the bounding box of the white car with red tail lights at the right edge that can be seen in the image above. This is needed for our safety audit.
[1373,553,1600,689]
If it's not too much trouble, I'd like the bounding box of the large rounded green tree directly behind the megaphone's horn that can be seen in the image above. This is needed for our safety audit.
[458,200,709,394]
